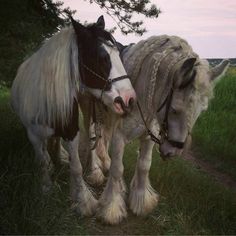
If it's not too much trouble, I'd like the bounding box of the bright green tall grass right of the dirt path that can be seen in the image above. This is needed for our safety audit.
[193,67,236,181]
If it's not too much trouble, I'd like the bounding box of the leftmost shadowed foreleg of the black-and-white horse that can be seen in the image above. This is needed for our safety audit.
[27,126,53,192]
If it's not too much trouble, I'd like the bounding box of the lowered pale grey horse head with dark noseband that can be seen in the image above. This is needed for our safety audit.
[159,57,229,158]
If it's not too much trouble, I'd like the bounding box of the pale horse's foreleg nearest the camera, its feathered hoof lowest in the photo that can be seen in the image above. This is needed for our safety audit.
[97,130,127,224]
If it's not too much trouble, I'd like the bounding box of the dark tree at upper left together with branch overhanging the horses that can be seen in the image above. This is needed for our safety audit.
[0,0,160,86]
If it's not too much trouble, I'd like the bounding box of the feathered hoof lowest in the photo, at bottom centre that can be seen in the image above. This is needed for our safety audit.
[97,194,127,225]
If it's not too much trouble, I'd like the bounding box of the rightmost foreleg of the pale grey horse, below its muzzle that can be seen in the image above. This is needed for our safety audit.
[129,137,158,215]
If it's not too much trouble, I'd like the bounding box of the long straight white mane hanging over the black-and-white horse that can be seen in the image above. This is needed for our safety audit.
[12,28,79,124]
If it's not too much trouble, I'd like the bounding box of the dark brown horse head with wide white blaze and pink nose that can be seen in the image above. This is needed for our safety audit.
[71,16,136,115]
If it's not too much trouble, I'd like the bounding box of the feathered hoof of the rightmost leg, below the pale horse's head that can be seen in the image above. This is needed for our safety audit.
[129,185,158,216]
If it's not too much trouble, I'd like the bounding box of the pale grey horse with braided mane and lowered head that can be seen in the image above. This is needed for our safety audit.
[82,35,229,224]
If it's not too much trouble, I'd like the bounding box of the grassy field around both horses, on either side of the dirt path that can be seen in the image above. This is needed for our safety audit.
[0,68,236,235]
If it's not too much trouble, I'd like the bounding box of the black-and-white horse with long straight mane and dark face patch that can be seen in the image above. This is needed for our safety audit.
[11,16,135,215]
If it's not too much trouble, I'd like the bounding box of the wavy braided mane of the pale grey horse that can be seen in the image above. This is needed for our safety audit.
[123,35,211,121]
